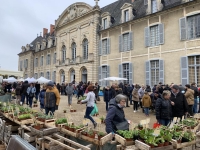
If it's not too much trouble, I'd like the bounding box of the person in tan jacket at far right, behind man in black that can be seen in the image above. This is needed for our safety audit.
[185,84,194,116]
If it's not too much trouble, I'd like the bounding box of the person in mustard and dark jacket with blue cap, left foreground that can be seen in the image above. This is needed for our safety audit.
[44,81,60,115]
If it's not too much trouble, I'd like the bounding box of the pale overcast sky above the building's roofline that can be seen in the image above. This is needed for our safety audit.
[0,0,117,70]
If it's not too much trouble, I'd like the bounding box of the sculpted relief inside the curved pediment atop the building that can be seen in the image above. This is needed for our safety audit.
[63,4,89,23]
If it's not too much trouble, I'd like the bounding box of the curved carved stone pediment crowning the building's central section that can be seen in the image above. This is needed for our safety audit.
[55,2,92,28]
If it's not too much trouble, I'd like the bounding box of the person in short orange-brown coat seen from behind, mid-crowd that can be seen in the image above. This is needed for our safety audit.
[142,91,151,117]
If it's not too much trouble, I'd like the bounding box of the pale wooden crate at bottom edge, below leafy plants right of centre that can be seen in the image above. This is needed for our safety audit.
[135,140,173,150]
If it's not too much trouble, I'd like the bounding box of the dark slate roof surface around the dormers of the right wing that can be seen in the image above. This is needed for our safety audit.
[100,0,190,27]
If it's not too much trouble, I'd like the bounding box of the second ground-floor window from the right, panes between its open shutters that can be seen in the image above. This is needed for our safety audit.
[150,60,160,86]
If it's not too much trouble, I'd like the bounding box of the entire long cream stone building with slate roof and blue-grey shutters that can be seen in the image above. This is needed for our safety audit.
[19,0,200,86]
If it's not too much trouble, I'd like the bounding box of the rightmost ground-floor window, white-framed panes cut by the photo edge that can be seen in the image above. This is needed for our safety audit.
[188,55,200,86]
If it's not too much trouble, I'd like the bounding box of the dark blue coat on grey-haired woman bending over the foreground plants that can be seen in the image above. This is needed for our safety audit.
[105,99,126,133]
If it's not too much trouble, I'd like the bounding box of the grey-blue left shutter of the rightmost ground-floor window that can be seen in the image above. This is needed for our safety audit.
[181,57,189,86]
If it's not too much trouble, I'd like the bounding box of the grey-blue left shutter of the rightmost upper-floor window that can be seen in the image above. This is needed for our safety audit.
[179,17,187,40]
